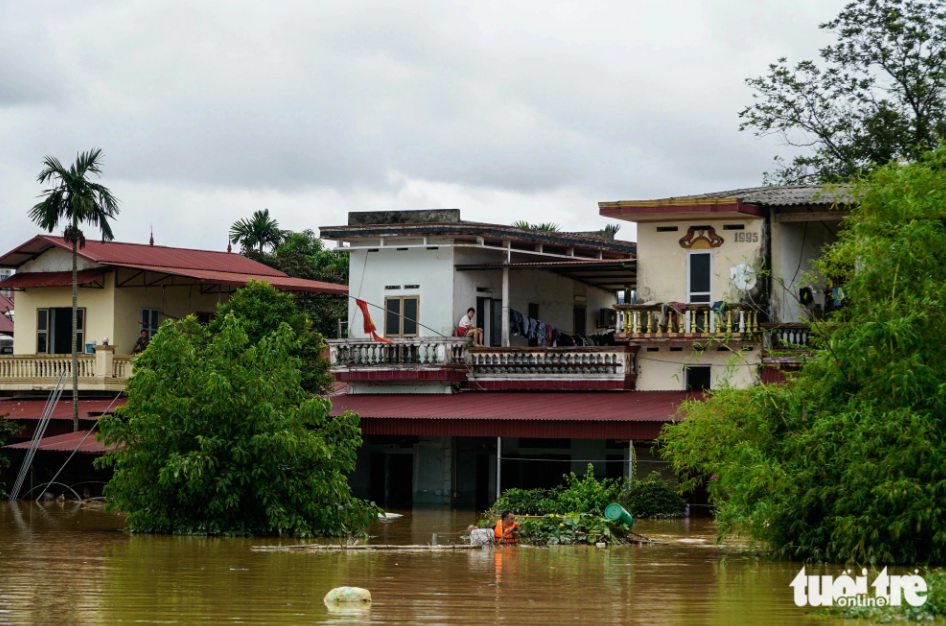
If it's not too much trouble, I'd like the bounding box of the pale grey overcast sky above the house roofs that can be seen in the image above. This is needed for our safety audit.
[0,0,845,251]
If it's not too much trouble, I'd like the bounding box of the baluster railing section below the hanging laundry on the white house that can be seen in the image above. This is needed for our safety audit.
[468,346,636,389]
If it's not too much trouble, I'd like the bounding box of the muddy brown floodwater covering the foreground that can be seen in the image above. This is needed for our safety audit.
[0,502,851,624]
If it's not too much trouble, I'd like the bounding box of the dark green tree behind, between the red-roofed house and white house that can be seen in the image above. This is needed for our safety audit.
[243,230,348,337]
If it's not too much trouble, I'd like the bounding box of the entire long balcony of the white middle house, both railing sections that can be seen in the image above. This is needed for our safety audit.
[328,337,636,393]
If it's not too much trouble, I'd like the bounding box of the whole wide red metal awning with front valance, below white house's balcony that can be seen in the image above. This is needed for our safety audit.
[331,391,702,439]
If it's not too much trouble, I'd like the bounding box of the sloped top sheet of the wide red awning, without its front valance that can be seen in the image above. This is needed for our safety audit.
[332,391,701,422]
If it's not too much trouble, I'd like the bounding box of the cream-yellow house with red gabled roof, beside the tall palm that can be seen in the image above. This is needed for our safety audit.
[0,235,348,498]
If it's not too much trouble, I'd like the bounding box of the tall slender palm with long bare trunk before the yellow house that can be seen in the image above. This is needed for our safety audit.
[30,148,119,430]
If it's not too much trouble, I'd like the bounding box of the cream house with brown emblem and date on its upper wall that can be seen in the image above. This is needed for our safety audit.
[599,186,851,390]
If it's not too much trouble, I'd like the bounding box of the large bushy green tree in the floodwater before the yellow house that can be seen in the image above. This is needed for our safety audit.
[97,312,378,536]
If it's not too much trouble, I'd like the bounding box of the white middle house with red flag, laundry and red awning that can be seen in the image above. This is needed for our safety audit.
[320,210,687,508]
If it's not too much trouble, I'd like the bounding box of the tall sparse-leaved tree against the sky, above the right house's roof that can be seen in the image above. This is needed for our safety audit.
[739,0,946,184]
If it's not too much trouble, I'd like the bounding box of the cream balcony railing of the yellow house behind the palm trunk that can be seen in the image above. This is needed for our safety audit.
[0,346,131,391]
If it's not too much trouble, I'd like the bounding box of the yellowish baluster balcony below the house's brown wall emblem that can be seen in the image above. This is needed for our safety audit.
[614,304,762,342]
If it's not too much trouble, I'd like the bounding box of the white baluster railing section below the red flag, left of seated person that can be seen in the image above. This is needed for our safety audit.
[328,337,469,369]
